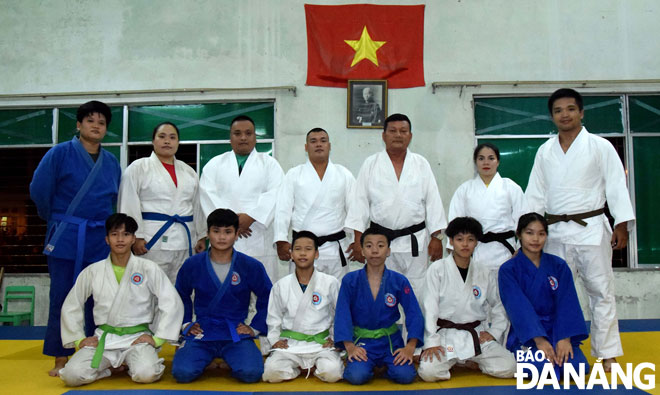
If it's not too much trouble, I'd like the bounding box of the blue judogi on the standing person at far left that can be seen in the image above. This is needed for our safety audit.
[30,137,121,356]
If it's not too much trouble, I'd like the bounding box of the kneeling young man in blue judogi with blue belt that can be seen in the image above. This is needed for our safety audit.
[172,209,272,383]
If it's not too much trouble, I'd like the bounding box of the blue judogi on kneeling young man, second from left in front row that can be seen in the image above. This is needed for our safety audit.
[172,250,272,383]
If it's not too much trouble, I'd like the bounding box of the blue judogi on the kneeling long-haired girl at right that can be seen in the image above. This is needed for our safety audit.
[499,251,589,377]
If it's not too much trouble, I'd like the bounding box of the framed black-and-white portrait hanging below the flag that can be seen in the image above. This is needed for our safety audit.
[346,80,387,129]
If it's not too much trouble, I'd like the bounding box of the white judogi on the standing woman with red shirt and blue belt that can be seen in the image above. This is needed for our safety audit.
[117,152,206,283]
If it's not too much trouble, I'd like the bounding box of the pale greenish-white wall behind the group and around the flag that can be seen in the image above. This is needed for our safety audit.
[0,0,660,317]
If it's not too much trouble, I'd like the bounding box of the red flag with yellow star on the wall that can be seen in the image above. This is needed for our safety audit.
[305,4,424,88]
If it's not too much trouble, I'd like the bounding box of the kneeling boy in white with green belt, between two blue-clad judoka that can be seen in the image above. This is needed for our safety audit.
[263,231,344,383]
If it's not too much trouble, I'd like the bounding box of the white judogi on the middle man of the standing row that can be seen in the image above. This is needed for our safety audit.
[273,160,355,279]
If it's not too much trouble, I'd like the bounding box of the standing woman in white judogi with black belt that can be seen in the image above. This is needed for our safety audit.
[448,143,528,276]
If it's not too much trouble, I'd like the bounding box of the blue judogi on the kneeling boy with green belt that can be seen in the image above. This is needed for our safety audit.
[335,266,424,384]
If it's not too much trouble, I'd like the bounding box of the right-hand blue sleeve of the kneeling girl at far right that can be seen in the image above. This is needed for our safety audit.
[550,257,588,344]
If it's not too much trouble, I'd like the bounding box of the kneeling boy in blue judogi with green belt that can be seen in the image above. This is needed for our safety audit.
[335,228,424,384]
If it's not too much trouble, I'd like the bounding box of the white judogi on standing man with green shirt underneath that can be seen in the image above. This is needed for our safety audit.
[199,149,284,281]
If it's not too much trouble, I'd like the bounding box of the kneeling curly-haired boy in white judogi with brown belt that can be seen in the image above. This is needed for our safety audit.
[418,217,516,381]
